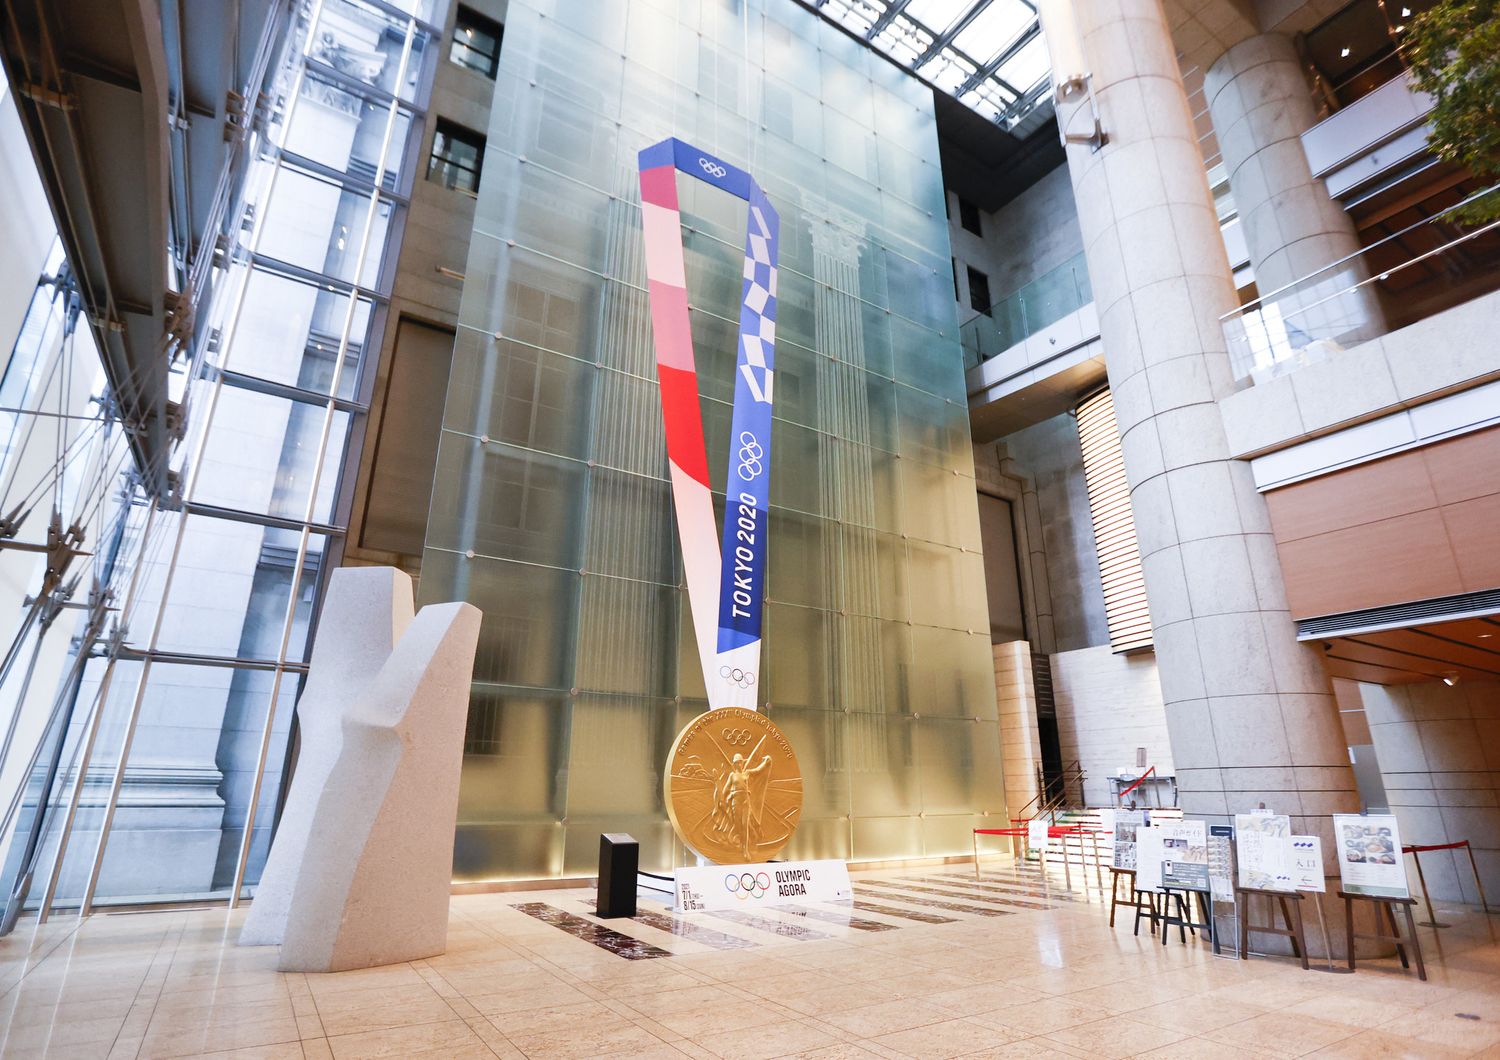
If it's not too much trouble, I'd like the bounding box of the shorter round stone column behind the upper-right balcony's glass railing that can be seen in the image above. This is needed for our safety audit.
[1203,33,1385,346]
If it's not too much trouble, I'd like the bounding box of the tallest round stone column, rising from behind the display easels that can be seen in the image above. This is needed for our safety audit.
[1044,0,1359,849]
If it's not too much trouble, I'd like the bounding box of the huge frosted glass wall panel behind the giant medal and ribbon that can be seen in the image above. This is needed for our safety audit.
[420,0,1005,880]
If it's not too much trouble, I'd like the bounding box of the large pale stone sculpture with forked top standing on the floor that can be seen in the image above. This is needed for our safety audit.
[240,568,480,972]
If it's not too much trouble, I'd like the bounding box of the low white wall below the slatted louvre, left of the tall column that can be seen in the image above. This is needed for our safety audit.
[1052,645,1176,807]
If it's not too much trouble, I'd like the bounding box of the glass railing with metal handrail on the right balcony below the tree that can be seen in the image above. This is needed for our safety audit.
[1220,184,1500,382]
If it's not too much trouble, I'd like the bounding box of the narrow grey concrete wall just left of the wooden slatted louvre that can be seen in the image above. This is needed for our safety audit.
[1002,414,1110,652]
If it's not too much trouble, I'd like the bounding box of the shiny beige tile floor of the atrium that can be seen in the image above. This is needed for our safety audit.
[0,862,1500,1060]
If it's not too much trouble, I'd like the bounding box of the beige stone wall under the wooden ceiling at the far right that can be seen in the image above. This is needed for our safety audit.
[1358,681,1500,903]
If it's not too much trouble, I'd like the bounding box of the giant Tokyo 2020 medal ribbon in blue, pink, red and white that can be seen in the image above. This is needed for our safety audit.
[639,138,780,711]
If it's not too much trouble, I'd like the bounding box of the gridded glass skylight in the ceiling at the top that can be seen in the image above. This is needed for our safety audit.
[813,0,1049,129]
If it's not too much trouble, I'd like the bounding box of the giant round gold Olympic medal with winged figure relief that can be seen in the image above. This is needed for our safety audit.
[663,706,803,865]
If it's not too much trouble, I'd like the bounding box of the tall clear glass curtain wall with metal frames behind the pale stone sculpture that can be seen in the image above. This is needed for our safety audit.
[6,0,446,912]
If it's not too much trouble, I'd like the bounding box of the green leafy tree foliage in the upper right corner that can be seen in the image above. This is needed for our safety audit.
[1406,0,1500,222]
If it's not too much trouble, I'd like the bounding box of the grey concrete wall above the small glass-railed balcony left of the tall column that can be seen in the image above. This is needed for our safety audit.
[948,165,1083,319]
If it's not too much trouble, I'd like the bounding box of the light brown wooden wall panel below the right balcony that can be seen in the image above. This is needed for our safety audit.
[1266,427,1500,618]
